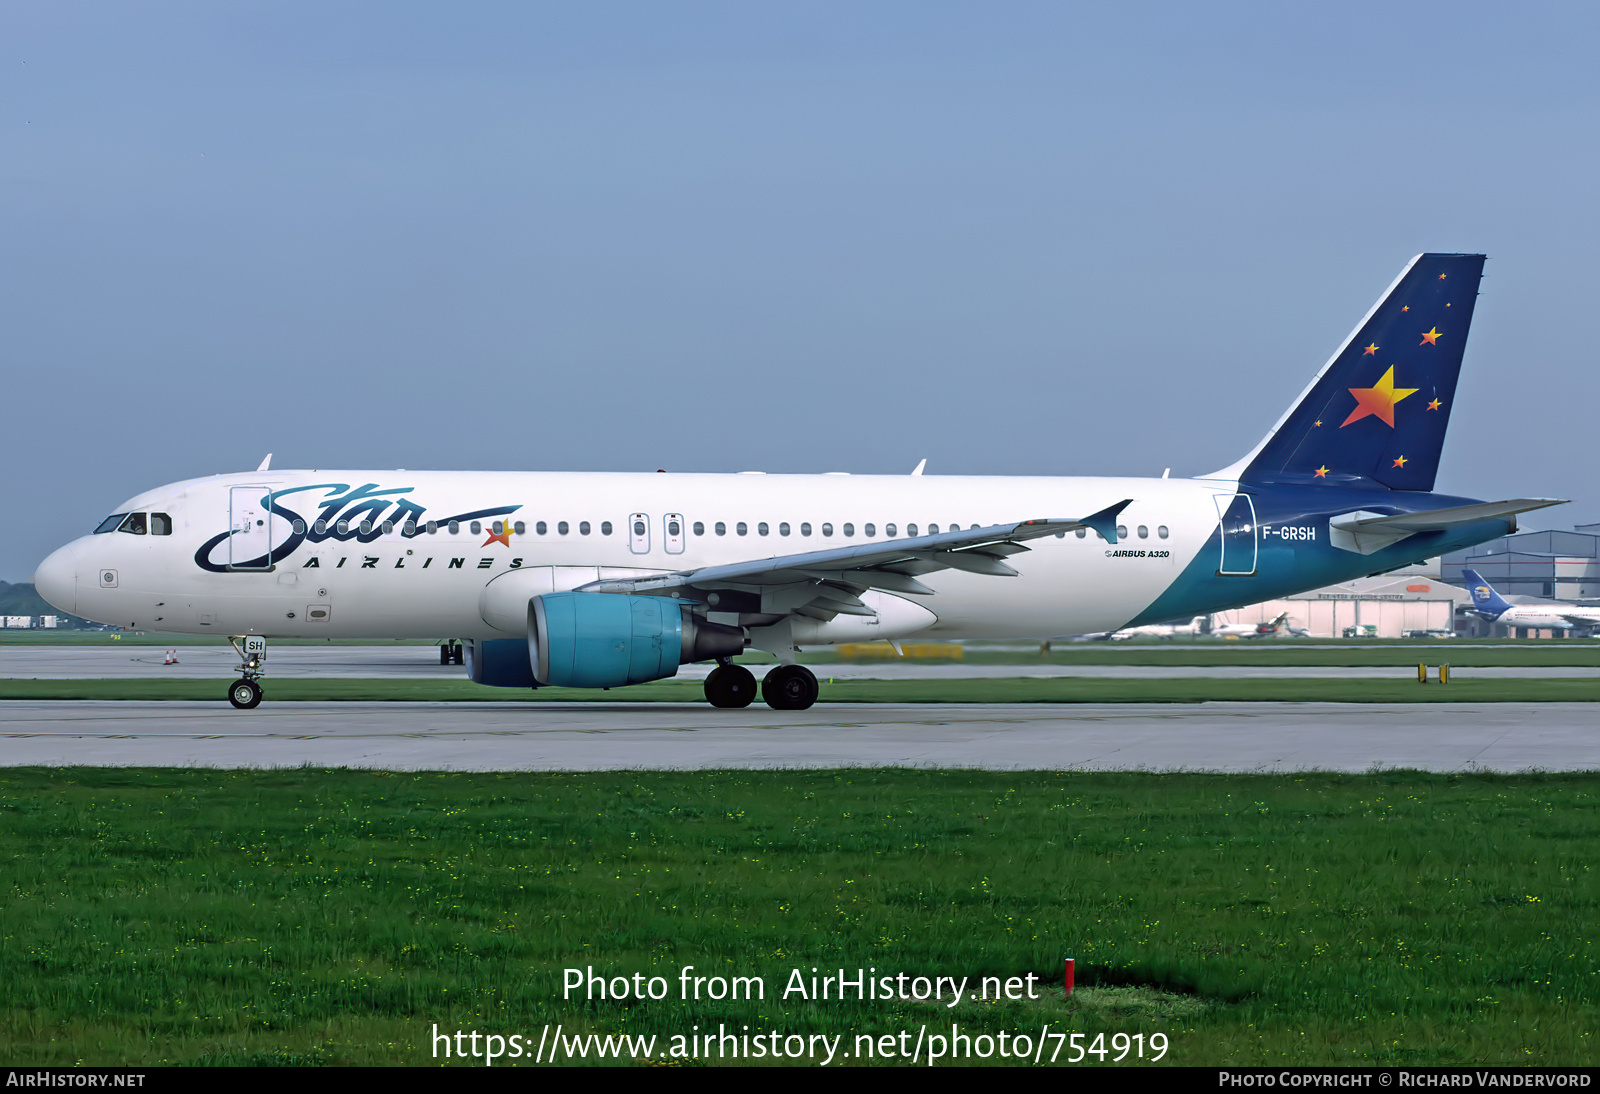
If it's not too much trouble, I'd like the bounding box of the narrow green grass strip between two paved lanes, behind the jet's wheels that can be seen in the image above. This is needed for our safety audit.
[0,665,1600,702]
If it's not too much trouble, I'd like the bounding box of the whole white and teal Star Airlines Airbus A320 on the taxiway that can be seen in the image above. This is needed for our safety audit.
[34,254,1558,710]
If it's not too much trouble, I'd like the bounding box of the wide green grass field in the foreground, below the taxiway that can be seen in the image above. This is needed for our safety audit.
[0,768,1600,1067]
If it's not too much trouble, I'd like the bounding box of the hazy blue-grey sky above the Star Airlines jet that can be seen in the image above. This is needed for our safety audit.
[0,0,1600,581]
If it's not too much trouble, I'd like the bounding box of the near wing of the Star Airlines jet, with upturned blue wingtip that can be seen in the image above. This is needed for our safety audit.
[579,497,1133,619]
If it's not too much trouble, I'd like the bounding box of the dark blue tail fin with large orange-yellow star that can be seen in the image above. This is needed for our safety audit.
[1229,254,1483,491]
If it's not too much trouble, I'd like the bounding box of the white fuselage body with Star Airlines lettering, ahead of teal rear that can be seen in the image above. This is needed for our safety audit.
[37,470,1235,643]
